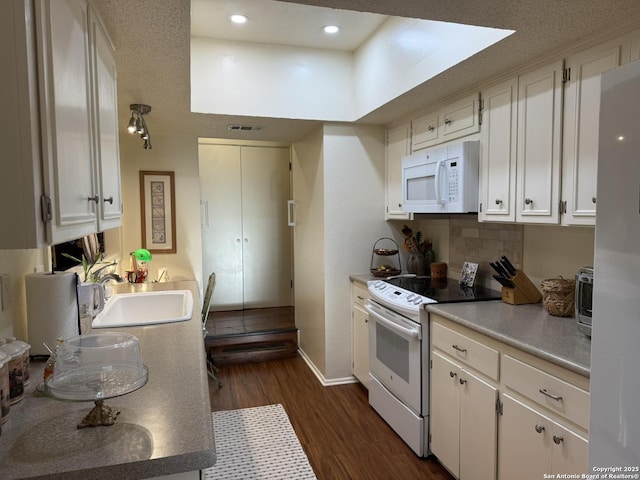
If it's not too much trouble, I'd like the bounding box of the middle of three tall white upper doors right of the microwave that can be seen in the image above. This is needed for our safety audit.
[516,62,562,224]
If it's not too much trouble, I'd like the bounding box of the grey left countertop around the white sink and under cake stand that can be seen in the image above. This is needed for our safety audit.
[0,281,216,480]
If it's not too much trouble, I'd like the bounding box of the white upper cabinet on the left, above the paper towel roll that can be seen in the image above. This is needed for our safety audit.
[0,0,121,248]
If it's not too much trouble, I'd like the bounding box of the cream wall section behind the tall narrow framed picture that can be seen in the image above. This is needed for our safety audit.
[119,131,202,285]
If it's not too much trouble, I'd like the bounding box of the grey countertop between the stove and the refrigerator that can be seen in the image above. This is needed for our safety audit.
[425,300,591,377]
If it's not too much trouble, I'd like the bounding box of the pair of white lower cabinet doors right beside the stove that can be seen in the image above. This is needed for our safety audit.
[430,351,498,480]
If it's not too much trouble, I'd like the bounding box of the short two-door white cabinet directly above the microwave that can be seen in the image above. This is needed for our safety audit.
[411,94,480,152]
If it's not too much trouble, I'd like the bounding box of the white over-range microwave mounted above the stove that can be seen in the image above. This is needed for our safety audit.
[402,141,480,213]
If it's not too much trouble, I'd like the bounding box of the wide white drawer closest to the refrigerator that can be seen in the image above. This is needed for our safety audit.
[502,355,589,429]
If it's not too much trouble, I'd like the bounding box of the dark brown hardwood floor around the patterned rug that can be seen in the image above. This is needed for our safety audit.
[209,356,453,480]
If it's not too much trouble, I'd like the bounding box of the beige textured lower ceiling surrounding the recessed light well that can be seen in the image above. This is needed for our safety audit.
[93,0,640,142]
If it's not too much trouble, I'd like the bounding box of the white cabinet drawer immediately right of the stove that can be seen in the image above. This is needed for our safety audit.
[431,323,499,381]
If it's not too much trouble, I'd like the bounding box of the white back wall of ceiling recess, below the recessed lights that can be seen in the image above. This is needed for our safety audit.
[191,38,354,121]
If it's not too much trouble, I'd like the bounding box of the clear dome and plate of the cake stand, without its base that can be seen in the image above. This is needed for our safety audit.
[47,332,148,401]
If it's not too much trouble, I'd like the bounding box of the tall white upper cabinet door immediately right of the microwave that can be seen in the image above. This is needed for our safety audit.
[478,78,518,222]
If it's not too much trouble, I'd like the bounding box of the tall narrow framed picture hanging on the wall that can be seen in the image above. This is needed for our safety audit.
[140,171,176,253]
